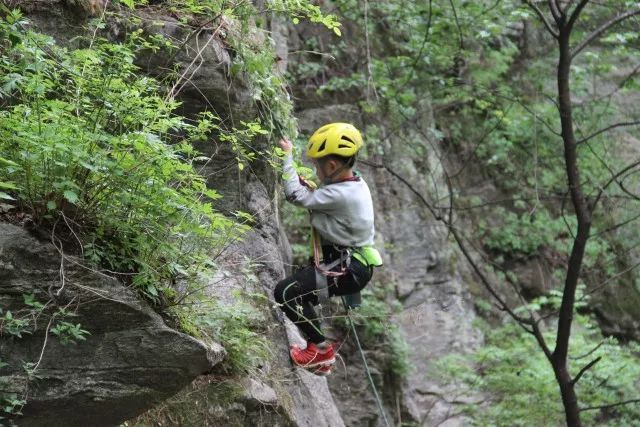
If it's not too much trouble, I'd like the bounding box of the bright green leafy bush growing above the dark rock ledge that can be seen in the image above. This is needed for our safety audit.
[0,12,245,301]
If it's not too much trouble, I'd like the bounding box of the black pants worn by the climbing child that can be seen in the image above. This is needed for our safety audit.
[273,257,373,344]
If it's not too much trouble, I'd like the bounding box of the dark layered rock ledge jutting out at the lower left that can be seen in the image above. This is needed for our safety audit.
[0,223,224,426]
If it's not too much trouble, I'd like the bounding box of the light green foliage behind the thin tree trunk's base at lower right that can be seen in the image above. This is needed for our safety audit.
[430,292,640,426]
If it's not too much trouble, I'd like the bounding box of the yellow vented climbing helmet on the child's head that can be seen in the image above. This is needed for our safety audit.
[307,123,362,159]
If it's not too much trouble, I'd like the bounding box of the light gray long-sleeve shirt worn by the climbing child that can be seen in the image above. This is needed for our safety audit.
[283,155,375,247]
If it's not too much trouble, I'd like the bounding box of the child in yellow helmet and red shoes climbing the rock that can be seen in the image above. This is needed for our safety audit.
[274,123,382,375]
